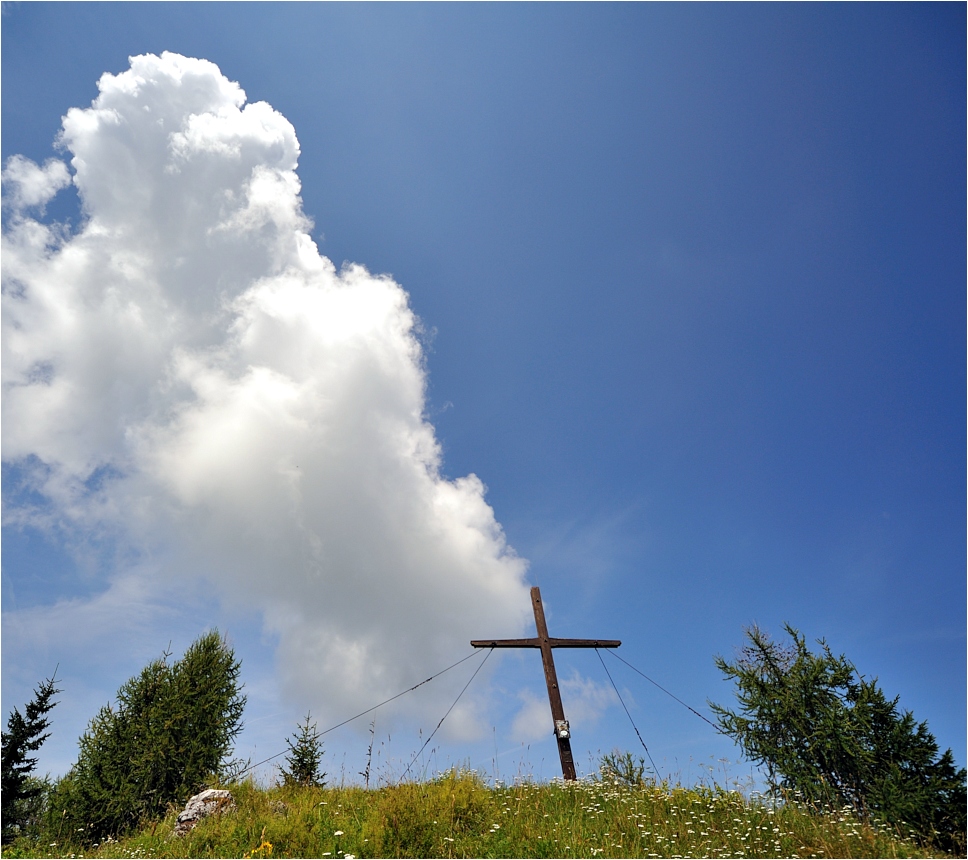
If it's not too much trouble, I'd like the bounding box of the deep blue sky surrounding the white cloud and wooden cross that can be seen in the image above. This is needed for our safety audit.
[2,4,966,779]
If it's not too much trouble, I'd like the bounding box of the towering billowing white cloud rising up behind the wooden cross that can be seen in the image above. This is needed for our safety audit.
[3,53,529,732]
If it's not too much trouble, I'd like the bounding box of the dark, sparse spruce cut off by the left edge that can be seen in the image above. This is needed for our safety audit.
[0,671,60,842]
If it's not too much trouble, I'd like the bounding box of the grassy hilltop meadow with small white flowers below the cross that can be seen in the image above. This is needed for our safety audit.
[3,771,943,860]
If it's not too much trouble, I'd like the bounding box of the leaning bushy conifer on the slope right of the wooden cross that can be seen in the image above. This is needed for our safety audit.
[710,625,966,852]
